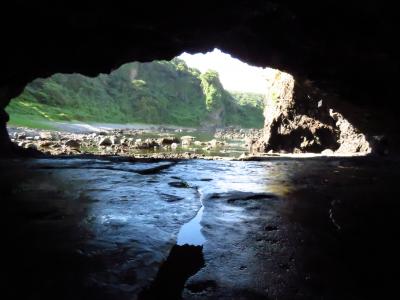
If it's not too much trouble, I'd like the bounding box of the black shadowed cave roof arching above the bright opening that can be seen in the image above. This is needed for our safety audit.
[0,0,399,155]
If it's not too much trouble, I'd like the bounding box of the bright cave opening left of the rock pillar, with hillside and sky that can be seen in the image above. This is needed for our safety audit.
[6,49,293,158]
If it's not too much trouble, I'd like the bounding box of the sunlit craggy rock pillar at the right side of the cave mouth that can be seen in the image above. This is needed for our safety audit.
[251,72,371,154]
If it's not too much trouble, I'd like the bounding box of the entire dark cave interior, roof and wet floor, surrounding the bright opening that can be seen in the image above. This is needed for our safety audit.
[0,0,399,299]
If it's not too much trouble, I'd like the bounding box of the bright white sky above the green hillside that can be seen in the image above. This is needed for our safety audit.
[179,49,275,94]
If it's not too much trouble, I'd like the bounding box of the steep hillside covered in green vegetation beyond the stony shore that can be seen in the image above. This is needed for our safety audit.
[7,58,263,128]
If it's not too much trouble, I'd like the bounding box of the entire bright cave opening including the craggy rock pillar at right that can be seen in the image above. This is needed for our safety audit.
[6,49,371,158]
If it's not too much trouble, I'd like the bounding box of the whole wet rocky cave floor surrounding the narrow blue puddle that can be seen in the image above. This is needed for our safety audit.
[0,157,400,299]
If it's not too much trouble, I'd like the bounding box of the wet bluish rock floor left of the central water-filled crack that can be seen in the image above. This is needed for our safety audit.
[1,159,200,299]
